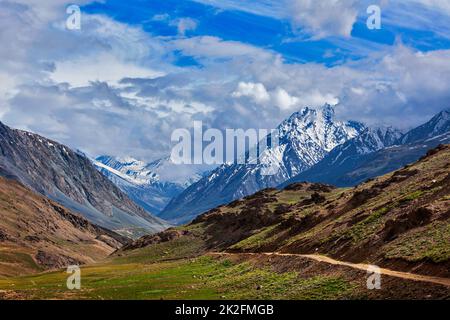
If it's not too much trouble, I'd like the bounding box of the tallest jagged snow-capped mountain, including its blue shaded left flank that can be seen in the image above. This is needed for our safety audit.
[160,105,365,223]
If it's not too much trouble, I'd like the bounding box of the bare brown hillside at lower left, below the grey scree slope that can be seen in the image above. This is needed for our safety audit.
[0,177,128,276]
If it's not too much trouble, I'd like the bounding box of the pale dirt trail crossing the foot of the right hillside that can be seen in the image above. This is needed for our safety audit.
[211,252,450,287]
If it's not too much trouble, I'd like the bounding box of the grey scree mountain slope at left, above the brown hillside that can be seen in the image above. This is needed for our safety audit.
[0,123,167,236]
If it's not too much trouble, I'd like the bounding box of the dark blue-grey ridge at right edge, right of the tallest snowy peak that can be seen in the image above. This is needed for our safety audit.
[281,111,450,187]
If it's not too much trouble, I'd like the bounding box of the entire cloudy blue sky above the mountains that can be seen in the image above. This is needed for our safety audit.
[0,0,450,160]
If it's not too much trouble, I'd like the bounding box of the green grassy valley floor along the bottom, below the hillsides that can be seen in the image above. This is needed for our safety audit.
[0,245,450,300]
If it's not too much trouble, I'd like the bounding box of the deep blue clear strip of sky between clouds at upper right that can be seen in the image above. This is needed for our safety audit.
[83,0,450,65]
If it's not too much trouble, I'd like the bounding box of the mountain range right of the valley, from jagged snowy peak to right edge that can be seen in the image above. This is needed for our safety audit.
[160,105,450,224]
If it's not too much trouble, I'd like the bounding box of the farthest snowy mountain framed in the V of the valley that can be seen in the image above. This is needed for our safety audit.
[93,156,207,215]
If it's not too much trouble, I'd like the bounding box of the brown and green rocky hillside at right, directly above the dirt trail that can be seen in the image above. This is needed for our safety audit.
[118,145,450,278]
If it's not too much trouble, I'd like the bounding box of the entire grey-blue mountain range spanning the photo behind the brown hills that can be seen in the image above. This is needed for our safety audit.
[6,105,450,237]
